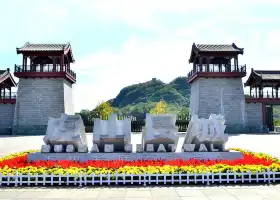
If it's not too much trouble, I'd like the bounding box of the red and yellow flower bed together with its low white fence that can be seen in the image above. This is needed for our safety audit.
[0,149,280,185]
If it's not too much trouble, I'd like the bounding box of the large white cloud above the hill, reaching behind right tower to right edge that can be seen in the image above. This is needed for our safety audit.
[74,26,280,111]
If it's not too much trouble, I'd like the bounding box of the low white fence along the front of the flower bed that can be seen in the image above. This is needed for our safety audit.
[0,171,280,187]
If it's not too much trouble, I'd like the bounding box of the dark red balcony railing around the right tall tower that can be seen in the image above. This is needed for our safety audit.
[188,64,246,78]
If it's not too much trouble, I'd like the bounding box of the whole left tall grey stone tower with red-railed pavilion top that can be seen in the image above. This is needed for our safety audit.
[13,42,76,135]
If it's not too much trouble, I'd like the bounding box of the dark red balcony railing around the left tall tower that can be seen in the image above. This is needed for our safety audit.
[15,64,76,79]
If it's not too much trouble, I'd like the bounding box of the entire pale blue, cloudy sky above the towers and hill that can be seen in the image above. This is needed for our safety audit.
[0,0,280,112]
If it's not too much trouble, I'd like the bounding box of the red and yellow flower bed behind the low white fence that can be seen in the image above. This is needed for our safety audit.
[0,149,280,175]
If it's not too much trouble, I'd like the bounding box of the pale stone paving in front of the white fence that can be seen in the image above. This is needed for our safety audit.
[0,184,280,200]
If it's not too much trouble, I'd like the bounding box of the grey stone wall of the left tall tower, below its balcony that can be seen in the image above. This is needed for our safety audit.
[13,78,73,135]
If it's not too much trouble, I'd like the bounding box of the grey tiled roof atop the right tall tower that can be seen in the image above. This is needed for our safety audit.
[194,43,243,52]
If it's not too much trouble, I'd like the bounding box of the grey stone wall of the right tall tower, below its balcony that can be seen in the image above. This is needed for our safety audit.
[190,78,248,133]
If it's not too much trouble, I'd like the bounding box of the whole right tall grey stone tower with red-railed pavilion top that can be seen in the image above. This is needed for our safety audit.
[188,43,248,133]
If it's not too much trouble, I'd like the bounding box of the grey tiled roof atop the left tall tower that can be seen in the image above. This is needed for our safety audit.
[17,42,70,52]
